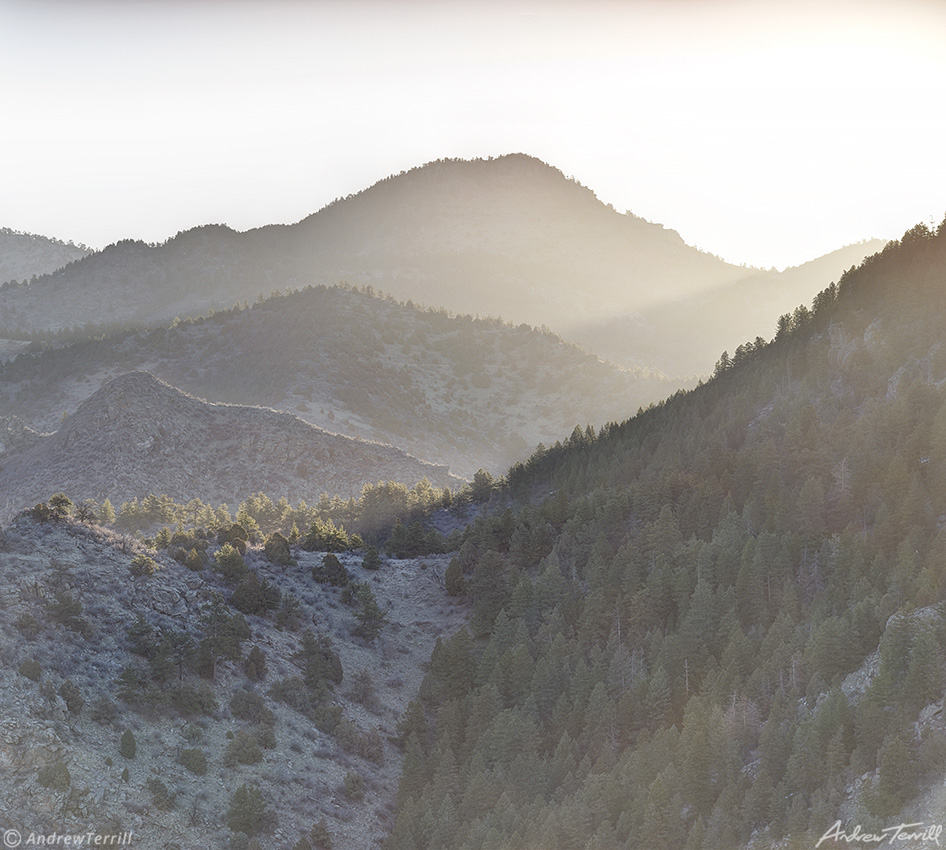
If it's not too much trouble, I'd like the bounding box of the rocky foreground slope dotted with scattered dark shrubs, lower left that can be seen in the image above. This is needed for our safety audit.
[0,506,465,850]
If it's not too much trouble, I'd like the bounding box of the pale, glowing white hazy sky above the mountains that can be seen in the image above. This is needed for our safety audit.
[0,0,946,267]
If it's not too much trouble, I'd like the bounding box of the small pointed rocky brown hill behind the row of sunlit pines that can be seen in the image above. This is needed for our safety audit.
[0,372,459,510]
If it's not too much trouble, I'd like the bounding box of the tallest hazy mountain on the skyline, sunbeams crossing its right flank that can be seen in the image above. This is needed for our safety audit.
[0,154,868,375]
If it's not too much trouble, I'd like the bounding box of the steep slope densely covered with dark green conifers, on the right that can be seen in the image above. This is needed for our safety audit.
[388,223,946,850]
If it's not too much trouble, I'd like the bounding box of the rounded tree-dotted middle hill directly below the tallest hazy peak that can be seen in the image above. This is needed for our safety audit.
[0,288,675,476]
